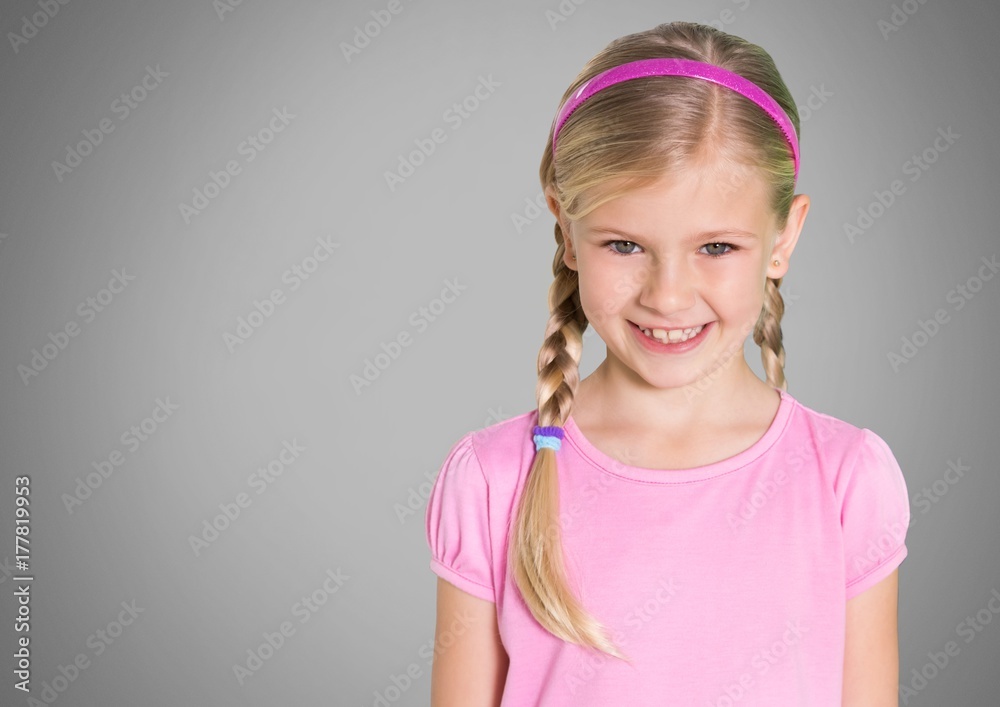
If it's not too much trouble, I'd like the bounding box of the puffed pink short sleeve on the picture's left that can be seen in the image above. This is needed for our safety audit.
[426,432,495,601]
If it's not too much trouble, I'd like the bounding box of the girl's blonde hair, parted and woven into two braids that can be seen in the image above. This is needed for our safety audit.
[508,22,801,660]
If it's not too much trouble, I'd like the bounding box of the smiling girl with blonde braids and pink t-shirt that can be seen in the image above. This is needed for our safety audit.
[426,22,909,707]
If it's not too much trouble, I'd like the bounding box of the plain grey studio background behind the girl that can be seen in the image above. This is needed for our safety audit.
[0,0,1000,706]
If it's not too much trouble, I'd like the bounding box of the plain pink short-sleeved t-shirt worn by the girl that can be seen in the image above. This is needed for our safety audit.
[426,391,910,707]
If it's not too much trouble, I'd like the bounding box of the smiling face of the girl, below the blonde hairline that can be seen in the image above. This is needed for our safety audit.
[564,163,797,387]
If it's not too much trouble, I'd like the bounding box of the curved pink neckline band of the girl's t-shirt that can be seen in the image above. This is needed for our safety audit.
[563,388,795,484]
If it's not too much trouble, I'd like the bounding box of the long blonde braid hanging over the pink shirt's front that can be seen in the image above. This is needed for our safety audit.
[509,223,628,660]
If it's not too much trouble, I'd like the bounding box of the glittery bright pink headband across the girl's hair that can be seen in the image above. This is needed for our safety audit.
[552,58,799,178]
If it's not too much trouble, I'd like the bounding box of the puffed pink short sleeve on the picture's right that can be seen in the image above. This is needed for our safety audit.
[840,429,910,599]
